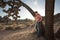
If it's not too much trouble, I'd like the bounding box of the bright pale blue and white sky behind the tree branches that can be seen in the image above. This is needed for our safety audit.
[0,0,60,19]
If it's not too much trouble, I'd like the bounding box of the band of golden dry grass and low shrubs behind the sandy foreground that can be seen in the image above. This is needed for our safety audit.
[0,22,34,30]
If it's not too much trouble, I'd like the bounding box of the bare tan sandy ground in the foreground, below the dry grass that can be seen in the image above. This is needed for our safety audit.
[0,27,44,40]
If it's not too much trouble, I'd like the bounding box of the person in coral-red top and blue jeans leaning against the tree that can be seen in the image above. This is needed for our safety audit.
[35,11,42,37]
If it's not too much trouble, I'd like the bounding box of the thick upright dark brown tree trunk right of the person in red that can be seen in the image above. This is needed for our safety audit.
[45,0,55,40]
